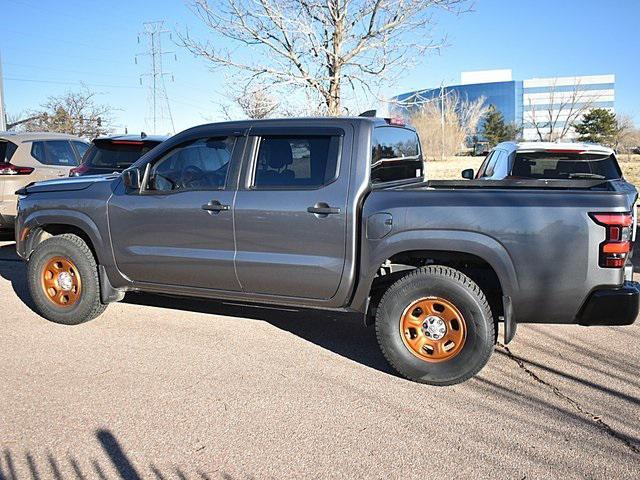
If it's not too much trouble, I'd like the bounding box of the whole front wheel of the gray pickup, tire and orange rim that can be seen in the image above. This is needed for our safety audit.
[27,234,106,325]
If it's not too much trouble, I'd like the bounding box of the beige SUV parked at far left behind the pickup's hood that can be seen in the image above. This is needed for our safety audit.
[0,132,89,230]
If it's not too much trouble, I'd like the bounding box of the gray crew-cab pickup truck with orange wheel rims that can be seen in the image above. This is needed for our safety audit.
[16,118,639,385]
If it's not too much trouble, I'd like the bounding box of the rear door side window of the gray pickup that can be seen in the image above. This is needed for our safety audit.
[253,135,340,188]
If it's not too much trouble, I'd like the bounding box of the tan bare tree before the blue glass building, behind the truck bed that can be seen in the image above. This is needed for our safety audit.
[411,91,487,159]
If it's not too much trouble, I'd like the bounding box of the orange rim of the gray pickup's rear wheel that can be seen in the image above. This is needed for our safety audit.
[400,297,467,362]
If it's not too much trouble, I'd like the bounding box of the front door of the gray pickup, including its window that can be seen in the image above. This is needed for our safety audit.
[109,135,241,291]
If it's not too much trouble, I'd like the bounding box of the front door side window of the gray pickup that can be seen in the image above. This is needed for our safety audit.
[148,137,234,192]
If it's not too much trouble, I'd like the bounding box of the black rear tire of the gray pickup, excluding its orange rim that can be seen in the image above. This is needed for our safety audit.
[375,265,495,385]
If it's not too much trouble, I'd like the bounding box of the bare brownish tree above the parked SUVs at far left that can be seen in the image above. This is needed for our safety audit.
[22,88,113,138]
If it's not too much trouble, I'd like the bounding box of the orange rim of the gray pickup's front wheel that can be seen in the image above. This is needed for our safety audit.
[40,257,82,307]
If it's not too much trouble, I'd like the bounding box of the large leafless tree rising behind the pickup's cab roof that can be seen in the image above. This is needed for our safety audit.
[180,0,467,115]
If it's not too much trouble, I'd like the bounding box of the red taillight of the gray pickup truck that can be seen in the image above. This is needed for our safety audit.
[590,212,633,268]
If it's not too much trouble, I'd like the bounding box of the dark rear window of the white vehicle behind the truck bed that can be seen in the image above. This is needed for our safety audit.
[511,151,622,180]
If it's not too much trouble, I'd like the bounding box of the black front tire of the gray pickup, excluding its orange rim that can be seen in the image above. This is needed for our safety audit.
[27,233,107,325]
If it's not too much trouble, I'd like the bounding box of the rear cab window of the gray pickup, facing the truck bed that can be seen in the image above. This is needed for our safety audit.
[371,127,424,183]
